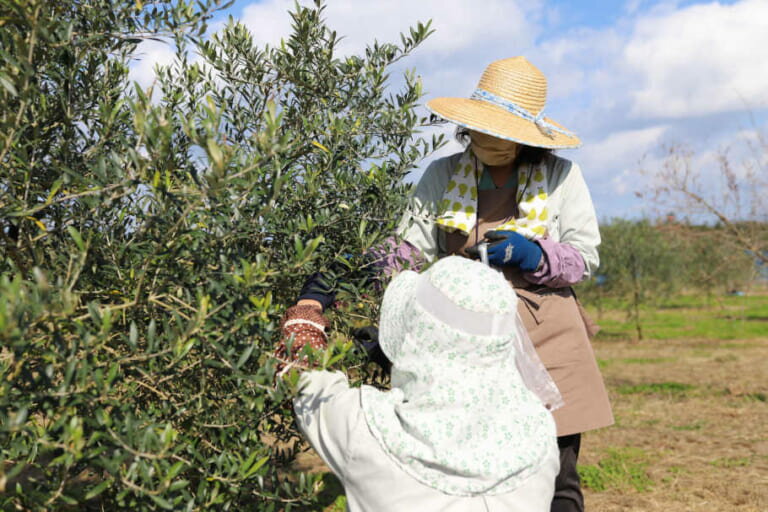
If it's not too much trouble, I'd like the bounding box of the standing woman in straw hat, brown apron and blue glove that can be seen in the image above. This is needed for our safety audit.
[390,57,613,511]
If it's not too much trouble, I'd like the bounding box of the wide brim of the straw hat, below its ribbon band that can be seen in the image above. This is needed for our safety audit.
[426,98,581,149]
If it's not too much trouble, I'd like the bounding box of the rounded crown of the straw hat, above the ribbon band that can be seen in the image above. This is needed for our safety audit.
[477,57,547,116]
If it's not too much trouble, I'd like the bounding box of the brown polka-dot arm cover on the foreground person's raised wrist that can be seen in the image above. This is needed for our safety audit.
[275,306,330,371]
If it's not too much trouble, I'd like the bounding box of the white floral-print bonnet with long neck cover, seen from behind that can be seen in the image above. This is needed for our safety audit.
[362,257,562,496]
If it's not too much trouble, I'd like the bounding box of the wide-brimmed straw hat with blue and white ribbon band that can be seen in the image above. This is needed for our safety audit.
[427,57,581,149]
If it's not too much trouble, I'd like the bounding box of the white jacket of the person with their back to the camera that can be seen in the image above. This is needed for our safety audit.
[294,371,560,512]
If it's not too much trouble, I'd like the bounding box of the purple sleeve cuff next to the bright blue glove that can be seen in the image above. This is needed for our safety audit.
[523,238,586,288]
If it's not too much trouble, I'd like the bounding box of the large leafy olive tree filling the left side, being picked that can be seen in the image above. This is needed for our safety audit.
[0,0,440,510]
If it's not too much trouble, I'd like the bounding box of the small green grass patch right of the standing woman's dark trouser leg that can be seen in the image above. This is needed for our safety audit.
[578,447,653,492]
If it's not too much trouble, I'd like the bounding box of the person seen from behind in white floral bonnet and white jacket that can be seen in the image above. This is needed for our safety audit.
[278,256,560,512]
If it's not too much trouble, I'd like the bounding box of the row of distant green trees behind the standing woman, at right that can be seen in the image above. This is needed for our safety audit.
[577,216,768,339]
